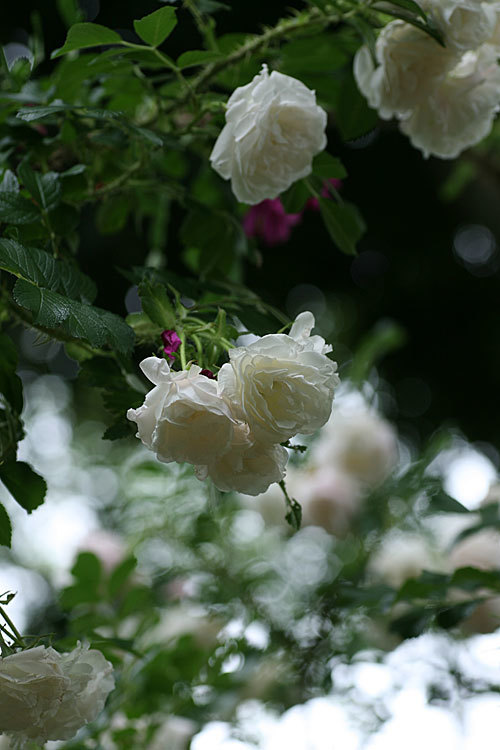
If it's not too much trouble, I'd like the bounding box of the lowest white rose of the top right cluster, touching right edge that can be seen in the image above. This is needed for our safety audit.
[401,44,500,159]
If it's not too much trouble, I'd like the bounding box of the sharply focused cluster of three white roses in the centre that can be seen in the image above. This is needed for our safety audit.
[127,312,339,495]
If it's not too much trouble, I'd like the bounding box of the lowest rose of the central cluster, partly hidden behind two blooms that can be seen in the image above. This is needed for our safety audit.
[196,424,288,495]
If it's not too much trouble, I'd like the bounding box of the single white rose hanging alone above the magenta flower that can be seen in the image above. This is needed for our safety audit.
[210,65,327,205]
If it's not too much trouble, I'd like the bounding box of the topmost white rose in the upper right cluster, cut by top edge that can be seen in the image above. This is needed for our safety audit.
[421,0,500,52]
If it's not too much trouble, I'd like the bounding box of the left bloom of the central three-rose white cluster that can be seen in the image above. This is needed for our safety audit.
[127,357,236,464]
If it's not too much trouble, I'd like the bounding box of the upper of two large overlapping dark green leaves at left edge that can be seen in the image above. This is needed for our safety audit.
[0,239,97,302]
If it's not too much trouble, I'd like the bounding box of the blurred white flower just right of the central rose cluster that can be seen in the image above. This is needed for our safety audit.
[311,393,398,487]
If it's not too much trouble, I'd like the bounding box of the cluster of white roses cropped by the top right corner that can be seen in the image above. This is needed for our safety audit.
[354,0,500,159]
